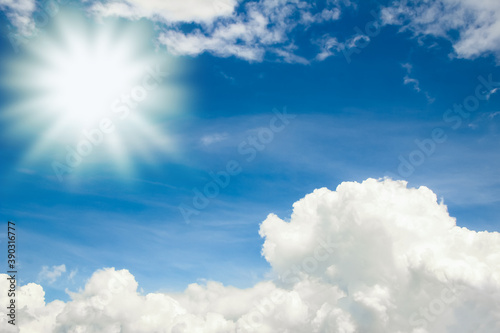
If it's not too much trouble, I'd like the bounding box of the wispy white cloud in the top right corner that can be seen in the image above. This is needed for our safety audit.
[381,0,500,60]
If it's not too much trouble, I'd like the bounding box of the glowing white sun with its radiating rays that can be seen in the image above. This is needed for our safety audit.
[4,9,182,179]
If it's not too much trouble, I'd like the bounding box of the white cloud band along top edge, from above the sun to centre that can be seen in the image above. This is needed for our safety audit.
[92,0,344,64]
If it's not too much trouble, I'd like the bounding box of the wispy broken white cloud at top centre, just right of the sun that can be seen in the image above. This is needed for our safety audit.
[153,0,340,63]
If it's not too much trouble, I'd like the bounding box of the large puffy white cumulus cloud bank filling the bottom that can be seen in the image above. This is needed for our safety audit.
[0,179,500,333]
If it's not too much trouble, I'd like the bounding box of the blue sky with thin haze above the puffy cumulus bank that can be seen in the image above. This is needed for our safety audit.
[0,1,500,301]
